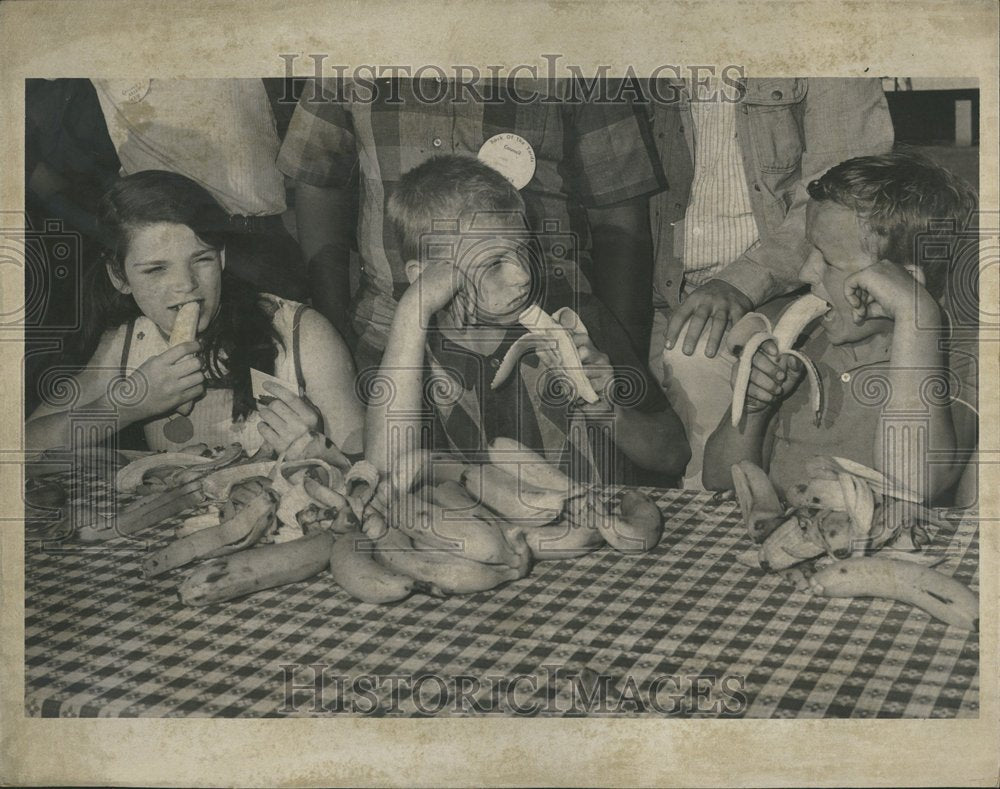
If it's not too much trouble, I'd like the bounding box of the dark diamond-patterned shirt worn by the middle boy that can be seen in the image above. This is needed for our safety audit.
[424,295,669,483]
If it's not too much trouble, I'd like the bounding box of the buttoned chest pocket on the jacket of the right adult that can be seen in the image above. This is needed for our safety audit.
[743,78,807,173]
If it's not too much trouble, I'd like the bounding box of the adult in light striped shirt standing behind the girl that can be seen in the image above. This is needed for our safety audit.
[92,79,307,301]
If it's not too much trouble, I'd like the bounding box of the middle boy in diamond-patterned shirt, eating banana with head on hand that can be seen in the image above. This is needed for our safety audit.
[365,155,689,484]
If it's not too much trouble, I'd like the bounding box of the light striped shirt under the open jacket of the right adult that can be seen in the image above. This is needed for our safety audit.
[684,90,759,291]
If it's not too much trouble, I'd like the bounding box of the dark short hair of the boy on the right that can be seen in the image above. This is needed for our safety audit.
[808,150,977,299]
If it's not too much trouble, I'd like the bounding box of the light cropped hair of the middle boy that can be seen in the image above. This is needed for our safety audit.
[386,154,524,261]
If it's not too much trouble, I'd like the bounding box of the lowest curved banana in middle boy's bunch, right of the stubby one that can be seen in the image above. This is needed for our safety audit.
[375,529,527,597]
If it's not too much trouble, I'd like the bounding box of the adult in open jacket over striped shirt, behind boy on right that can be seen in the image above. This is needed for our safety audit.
[650,78,893,488]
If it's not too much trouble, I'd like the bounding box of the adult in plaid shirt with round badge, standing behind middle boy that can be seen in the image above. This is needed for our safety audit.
[278,79,663,370]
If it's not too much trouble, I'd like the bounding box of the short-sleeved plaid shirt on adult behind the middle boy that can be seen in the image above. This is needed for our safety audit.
[278,80,665,349]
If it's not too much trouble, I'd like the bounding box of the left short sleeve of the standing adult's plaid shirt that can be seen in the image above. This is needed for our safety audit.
[278,80,358,187]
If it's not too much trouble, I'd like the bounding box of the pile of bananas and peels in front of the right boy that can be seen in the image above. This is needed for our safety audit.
[732,457,979,630]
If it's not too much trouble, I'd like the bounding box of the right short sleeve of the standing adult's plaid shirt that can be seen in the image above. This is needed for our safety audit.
[566,95,667,207]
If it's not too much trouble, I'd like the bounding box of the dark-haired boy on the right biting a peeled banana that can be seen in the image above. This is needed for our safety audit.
[703,151,977,503]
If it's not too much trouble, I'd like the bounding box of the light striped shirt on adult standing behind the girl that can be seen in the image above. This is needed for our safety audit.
[92,79,285,216]
